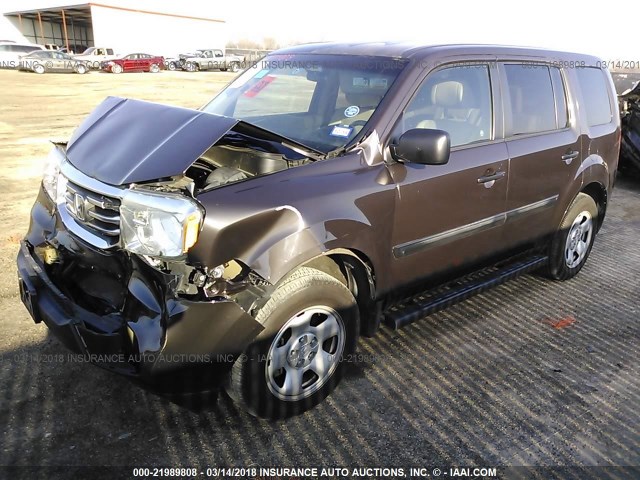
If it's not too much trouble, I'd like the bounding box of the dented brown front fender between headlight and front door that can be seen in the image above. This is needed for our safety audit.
[188,152,395,284]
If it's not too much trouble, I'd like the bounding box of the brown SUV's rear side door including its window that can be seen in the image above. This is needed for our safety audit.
[499,62,584,247]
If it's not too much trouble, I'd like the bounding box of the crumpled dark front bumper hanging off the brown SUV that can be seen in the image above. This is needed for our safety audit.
[17,189,263,383]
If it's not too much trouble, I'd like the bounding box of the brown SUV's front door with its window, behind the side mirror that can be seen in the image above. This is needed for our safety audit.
[389,62,509,282]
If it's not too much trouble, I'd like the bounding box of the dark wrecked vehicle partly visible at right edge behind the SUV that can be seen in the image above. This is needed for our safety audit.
[613,74,640,173]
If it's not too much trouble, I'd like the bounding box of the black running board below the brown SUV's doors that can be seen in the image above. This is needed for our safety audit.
[384,255,548,330]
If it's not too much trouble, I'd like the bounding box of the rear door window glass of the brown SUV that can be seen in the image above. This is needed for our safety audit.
[504,64,566,135]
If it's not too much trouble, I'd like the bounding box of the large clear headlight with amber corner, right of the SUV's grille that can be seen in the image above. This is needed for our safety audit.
[120,190,203,258]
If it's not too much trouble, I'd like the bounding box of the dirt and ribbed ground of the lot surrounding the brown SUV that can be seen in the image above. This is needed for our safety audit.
[0,71,640,478]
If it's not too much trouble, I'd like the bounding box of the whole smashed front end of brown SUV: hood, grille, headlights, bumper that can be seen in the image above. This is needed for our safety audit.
[18,98,313,381]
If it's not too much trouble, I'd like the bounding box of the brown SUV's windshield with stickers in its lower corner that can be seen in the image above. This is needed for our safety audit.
[203,55,406,153]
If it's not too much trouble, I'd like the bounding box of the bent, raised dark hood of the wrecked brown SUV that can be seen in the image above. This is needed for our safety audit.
[67,97,238,185]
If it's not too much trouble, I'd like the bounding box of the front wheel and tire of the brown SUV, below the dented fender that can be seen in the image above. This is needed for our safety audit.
[225,267,360,419]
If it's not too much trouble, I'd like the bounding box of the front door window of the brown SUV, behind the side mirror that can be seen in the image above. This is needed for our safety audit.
[397,64,493,147]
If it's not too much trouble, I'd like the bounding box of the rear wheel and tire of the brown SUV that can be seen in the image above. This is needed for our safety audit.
[544,193,598,280]
